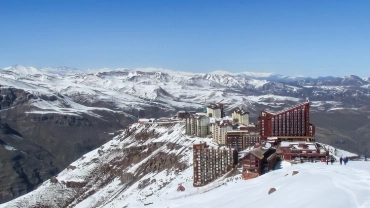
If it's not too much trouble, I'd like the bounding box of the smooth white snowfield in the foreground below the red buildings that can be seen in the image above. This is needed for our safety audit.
[150,161,370,208]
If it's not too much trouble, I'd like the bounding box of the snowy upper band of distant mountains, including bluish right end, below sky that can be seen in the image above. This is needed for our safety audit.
[0,65,370,113]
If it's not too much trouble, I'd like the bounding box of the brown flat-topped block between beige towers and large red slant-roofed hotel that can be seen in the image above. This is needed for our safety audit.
[226,130,260,151]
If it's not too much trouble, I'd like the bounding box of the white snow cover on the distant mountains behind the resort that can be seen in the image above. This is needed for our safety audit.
[0,65,358,116]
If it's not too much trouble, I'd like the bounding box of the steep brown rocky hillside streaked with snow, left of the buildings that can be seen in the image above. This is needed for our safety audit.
[0,123,220,207]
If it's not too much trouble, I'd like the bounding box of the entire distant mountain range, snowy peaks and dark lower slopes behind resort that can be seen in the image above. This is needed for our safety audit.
[0,65,370,203]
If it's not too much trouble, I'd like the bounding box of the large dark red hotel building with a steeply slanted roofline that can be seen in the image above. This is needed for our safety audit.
[258,102,315,141]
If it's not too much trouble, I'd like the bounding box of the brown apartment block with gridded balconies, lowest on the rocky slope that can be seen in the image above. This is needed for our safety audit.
[193,143,233,187]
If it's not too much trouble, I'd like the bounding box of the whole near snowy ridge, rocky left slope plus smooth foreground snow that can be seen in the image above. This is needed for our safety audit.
[0,123,370,208]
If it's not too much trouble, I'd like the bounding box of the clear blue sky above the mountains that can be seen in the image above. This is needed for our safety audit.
[0,0,370,77]
